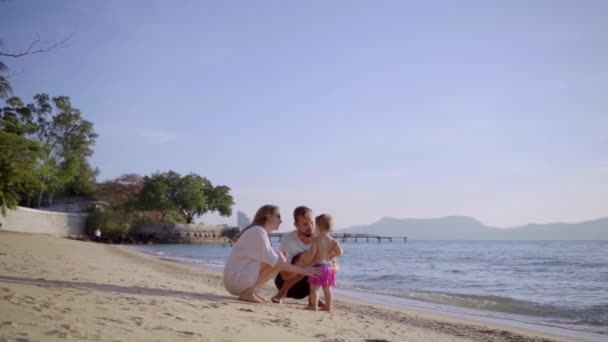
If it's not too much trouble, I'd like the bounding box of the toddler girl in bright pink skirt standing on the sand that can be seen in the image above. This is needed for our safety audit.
[306,214,344,311]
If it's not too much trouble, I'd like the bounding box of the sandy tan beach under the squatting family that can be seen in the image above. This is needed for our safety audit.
[0,232,574,342]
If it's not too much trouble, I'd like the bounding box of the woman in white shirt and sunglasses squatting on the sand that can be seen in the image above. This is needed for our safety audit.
[224,205,320,303]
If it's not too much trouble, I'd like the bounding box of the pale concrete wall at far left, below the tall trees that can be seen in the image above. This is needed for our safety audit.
[0,207,87,236]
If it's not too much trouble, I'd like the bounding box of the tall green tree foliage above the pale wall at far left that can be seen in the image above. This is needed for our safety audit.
[0,94,98,214]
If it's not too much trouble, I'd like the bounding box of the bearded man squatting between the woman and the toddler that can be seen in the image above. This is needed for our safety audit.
[272,206,315,304]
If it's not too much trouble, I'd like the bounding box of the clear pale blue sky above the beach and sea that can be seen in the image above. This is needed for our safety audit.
[0,0,608,230]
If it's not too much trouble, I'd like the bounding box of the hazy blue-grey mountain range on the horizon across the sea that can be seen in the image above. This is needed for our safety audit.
[336,216,608,240]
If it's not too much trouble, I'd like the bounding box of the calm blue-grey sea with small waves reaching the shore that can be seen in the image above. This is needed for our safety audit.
[130,240,608,341]
